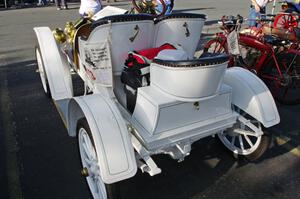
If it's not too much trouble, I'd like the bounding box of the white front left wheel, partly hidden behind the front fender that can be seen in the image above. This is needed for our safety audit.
[35,47,51,97]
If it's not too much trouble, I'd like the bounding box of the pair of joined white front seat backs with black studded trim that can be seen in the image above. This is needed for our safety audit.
[84,13,205,75]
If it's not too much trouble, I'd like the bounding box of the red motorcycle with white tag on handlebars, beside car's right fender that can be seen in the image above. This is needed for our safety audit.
[204,16,300,105]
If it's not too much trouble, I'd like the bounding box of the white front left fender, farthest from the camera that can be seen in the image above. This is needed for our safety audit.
[33,27,73,100]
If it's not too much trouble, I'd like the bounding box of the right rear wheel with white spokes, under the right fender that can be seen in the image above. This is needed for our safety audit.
[218,108,270,160]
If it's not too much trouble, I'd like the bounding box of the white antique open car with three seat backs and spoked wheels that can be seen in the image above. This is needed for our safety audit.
[34,7,280,198]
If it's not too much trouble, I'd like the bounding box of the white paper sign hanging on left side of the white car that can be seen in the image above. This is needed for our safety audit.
[79,40,113,86]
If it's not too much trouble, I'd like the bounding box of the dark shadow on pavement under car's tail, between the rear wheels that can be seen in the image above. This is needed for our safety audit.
[119,138,240,199]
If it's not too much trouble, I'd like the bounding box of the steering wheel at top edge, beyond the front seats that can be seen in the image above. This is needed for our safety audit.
[132,0,167,17]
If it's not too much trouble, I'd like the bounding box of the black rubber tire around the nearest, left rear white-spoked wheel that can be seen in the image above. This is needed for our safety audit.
[76,118,120,199]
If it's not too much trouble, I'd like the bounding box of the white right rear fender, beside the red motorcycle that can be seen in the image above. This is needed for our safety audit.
[224,67,280,128]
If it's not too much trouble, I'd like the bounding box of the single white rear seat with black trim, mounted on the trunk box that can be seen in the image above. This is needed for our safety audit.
[150,54,228,102]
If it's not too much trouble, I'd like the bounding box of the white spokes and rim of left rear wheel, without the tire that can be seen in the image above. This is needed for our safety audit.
[78,120,107,199]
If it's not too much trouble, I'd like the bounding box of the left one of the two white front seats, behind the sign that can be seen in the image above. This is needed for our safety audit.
[88,14,154,75]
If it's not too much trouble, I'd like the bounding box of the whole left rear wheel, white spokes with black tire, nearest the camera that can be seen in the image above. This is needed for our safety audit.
[77,118,119,199]
